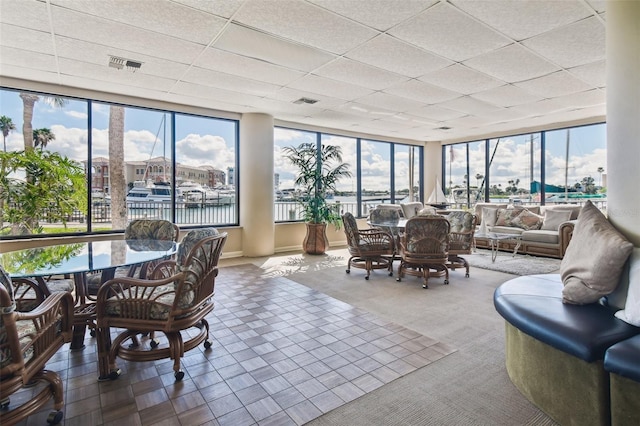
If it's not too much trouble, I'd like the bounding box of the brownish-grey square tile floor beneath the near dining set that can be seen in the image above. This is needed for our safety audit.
[12,264,454,426]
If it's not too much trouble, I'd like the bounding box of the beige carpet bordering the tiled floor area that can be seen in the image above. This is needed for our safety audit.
[220,249,556,426]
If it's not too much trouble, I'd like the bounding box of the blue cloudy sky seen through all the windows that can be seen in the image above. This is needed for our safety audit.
[0,90,606,191]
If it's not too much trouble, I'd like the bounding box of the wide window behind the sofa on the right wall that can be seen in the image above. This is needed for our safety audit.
[442,124,606,207]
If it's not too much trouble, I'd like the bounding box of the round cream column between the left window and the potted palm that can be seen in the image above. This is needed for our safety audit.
[239,114,275,257]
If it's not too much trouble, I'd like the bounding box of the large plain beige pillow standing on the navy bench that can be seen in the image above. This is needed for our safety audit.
[560,201,633,305]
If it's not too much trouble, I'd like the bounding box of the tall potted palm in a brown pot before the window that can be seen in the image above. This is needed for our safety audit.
[283,143,352,254]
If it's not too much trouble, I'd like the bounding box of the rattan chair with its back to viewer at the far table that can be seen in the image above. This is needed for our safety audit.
[397,215,451,288]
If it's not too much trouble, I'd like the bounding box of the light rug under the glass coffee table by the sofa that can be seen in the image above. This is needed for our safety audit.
[463,249,561,275]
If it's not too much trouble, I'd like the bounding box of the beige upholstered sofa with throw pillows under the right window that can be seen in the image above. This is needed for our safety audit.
[475,203,581,259]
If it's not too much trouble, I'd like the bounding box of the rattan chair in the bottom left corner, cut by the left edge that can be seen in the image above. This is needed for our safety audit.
[0,267,73,425]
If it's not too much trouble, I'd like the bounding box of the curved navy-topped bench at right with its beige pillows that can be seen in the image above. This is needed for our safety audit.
[494,203,640,426]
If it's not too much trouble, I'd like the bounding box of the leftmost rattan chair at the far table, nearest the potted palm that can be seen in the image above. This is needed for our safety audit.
[342,212,395,280]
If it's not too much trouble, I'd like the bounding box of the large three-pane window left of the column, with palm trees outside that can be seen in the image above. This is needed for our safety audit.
[0,85,238,237]
